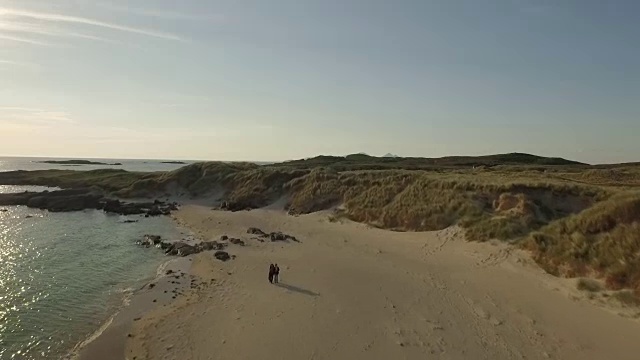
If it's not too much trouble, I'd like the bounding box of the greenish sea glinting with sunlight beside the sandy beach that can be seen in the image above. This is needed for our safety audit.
[0,157,191,360]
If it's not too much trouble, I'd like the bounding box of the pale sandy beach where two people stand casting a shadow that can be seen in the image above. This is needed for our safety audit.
[127,206,640,360]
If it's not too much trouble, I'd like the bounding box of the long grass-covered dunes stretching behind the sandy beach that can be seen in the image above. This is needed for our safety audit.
[0,154,640,296]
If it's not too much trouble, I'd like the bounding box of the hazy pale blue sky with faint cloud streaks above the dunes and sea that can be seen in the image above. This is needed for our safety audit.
[0,0,640,163]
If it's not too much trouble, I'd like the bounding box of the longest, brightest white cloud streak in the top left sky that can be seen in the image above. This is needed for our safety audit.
[0,7,184,41]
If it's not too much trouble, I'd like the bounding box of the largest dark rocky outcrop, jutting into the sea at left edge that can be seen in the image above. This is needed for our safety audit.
[0,189,178,216]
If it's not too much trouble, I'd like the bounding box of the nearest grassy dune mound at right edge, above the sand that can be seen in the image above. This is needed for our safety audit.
[525,191,640,294]
